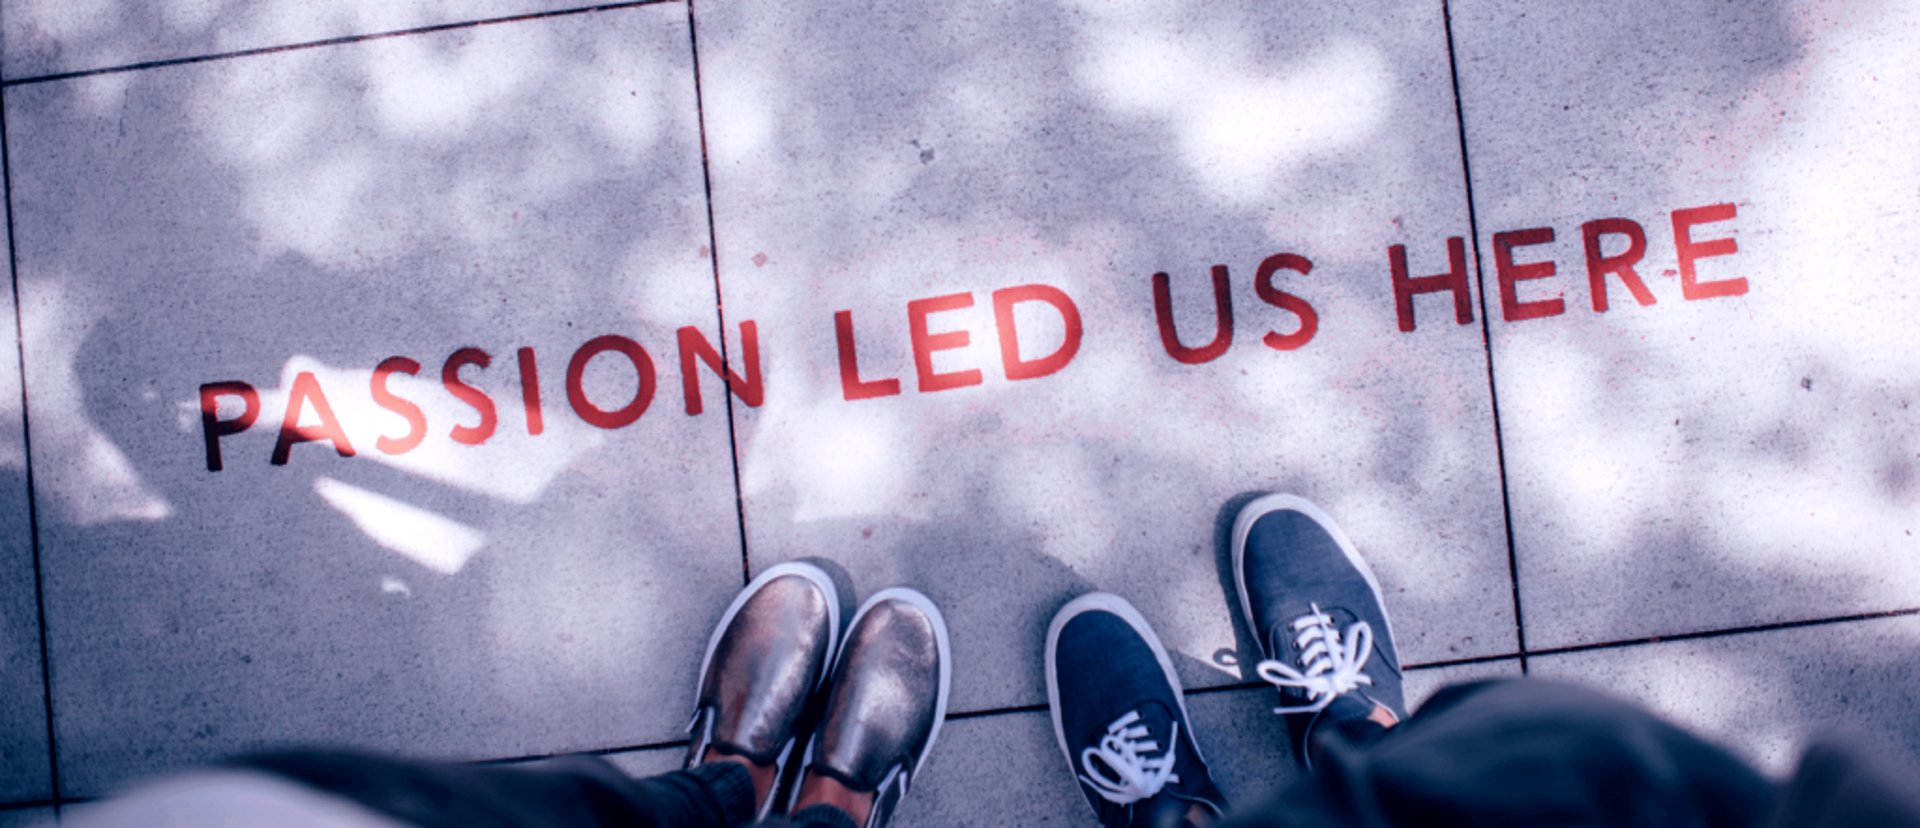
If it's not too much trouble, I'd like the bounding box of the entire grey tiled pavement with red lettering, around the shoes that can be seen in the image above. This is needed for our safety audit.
[0,0,1920,824]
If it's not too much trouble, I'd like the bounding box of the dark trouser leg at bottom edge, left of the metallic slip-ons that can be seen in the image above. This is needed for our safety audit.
[232,751,753,828]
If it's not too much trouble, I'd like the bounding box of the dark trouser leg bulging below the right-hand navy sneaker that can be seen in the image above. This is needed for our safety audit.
[1229,680,1774,826]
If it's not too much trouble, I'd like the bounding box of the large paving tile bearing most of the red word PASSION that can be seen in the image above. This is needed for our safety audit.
[8,6,741,795]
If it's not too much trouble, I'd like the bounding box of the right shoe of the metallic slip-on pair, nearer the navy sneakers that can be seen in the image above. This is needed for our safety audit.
[791,588,952,828]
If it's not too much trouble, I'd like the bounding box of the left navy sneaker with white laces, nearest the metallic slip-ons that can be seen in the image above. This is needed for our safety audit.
[1046,592,1227,828]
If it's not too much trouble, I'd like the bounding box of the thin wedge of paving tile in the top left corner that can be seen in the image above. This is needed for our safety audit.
[0,0,601,79]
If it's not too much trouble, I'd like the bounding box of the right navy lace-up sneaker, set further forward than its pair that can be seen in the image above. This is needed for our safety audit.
[1233,494,1405,768]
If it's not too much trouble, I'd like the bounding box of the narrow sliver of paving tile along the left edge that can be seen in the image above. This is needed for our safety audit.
[0,174,54,803]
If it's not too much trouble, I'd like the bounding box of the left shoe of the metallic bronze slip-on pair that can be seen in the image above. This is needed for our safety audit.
[685,561,839,818]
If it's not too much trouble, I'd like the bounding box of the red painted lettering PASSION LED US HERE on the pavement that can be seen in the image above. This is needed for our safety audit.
[200,204,1747,471]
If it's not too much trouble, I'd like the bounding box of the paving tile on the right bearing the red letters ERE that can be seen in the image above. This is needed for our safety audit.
[1453,0,1920,647]
